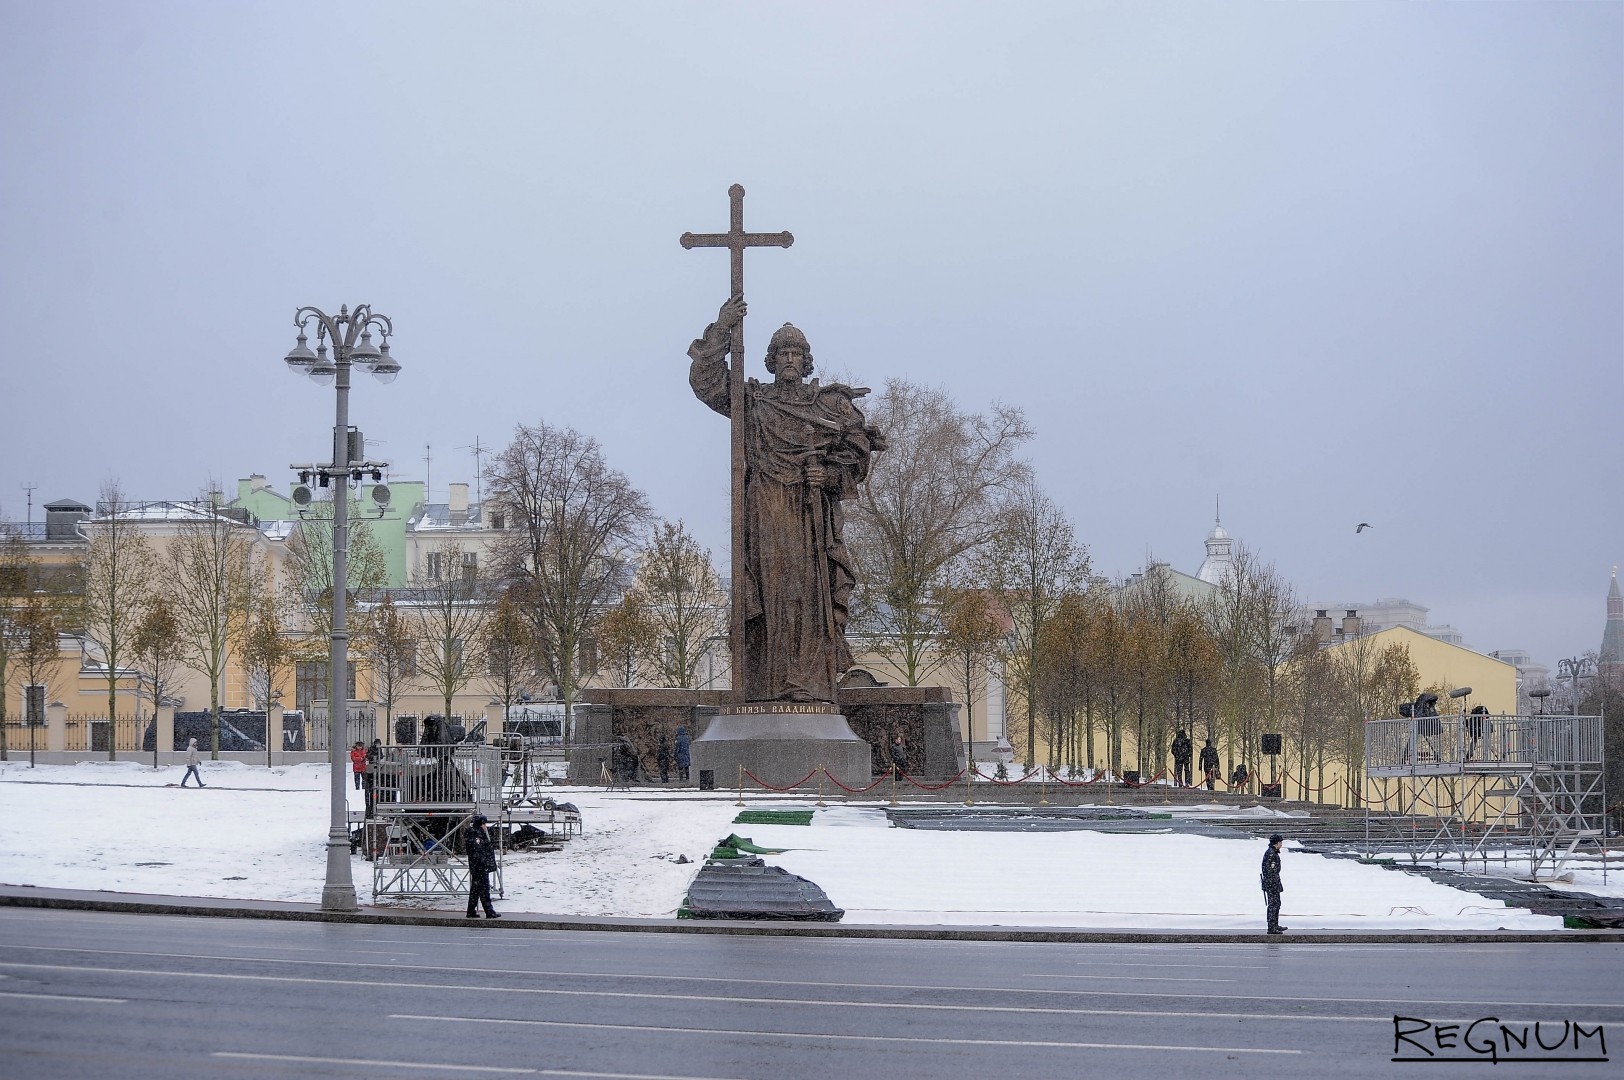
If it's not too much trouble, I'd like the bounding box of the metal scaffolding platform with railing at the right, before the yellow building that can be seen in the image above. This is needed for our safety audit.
[1364,713,1606,877]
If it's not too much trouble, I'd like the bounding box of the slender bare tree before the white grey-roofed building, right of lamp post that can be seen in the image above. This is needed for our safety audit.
[409,539,490,718]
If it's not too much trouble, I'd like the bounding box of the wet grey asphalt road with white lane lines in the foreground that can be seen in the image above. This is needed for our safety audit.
[0,908,1624,1080]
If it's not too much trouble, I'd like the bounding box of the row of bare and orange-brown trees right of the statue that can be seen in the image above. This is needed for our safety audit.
[848,382,1418,793]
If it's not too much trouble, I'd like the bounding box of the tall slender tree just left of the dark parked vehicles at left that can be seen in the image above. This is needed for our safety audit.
[80,479,156,760]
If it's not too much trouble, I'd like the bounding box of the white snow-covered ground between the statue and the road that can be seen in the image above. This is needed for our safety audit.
[0,760,1598,931]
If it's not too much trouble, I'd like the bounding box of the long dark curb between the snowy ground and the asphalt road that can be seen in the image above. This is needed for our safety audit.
[0,885,1624,945]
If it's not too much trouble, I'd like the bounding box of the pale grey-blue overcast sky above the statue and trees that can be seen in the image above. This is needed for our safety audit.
[0,0,1624,666]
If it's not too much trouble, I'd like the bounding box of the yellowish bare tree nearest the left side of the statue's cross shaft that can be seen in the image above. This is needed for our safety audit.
[633,521,728,689]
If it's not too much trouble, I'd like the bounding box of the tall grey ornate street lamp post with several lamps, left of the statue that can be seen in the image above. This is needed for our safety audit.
[284,304,401,911]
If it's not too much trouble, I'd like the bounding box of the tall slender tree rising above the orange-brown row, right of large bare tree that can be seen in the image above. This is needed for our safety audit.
[984,486,1088,768]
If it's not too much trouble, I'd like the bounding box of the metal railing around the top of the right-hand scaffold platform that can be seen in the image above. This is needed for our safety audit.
[1364,713,1605,775]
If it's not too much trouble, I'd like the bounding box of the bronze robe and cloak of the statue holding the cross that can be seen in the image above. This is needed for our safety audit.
[689,325,875,702]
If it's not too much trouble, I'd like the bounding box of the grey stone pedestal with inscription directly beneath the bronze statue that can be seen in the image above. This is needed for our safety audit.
[692,702,872,791]
